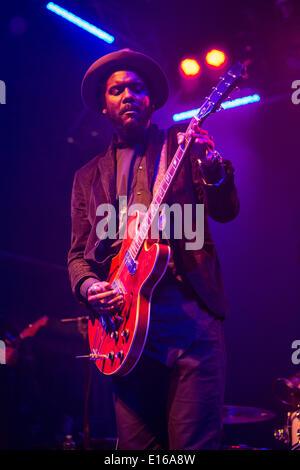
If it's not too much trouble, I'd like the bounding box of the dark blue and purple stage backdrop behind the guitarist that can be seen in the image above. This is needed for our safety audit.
[0,0,300,449]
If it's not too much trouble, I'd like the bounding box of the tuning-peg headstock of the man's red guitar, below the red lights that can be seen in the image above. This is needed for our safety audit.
[196,62,245,121]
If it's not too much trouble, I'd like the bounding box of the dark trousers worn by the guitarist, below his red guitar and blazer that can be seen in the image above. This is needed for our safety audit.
[113,320,225,450]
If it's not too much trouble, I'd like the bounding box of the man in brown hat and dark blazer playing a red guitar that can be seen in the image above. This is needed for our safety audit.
[68,49,239,450]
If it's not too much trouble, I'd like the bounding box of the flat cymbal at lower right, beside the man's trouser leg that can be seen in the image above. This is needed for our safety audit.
[223,405,276,424]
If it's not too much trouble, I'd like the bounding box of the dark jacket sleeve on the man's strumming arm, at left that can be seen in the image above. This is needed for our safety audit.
[68,171,99,301]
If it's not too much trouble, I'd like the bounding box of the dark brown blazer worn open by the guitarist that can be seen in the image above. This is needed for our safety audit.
[68,125,239,318]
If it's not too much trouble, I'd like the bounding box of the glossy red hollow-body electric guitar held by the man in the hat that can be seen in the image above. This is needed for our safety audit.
[85,63,244,376]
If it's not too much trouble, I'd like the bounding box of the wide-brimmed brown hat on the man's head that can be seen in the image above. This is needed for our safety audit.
[81,49,169,113]
